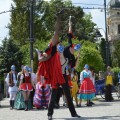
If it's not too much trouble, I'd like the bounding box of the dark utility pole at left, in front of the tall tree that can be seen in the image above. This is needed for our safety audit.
[30,0,34,68]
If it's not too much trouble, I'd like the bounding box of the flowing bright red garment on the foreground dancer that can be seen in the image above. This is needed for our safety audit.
[37,43,65,88]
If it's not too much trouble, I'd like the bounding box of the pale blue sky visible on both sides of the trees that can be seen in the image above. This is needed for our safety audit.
[0,0,110,44]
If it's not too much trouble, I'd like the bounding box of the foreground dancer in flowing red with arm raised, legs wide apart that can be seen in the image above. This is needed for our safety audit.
[37,12,80,120]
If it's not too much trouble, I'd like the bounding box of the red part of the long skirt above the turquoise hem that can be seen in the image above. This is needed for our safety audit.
[79,78,95,94]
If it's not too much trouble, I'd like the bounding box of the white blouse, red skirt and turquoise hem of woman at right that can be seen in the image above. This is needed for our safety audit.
[78,70,95,100]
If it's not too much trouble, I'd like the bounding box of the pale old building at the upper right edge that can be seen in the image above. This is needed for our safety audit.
[107,0,120,42]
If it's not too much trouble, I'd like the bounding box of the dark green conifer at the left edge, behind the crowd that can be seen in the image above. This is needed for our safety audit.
[0,39,23,74]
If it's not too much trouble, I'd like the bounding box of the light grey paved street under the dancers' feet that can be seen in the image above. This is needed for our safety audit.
[0,95,120,120]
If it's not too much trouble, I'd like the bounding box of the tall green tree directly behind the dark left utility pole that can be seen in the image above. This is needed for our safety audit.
[8,0,47,46]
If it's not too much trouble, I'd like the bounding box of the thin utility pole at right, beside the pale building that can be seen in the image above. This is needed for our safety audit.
[104,0,109,66]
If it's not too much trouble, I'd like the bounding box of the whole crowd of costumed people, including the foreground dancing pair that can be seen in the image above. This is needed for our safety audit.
[2,12,117,120]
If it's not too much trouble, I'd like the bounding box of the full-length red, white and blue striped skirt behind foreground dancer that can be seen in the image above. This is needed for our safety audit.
[33,82,50,108]
